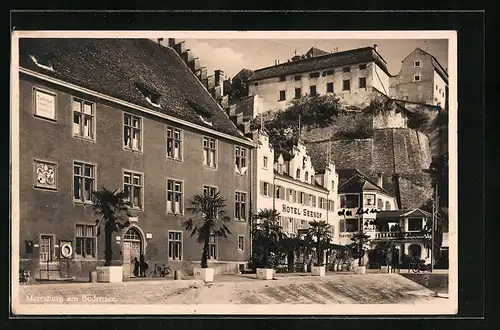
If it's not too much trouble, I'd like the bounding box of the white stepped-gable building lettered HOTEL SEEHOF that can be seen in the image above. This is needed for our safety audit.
[252,130,339,236]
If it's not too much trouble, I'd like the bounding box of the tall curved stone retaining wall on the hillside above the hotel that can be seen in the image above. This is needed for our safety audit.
[307,128,432,208]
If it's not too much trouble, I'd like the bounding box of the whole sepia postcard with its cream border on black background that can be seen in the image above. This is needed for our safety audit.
[11,31,458,315]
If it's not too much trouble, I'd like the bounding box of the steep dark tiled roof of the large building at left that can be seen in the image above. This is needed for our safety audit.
[19,38,244,138]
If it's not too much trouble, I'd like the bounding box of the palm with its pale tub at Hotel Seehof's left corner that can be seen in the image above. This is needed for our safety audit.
[252,209,284,280]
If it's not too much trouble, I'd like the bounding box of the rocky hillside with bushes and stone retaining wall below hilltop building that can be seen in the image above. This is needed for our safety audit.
[257,88,446,208]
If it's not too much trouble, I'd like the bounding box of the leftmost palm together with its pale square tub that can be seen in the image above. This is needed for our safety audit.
[92,188,130,283]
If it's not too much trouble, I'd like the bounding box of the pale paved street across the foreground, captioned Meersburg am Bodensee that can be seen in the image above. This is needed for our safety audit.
[16,274,446,304]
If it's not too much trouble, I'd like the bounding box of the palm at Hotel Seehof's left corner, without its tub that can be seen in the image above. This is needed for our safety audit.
[252,209,284,268]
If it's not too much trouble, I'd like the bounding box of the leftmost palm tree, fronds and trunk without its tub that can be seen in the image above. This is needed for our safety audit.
[92,188,130,266]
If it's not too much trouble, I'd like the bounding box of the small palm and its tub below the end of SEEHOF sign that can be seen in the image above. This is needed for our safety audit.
[309,221,332,276]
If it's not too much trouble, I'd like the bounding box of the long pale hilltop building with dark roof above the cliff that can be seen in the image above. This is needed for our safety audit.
[247,45,391,117]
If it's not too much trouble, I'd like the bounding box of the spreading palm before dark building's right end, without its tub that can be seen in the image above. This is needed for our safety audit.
[183,191,231,268]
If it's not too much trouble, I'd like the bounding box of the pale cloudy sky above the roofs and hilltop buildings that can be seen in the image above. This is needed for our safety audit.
[181,39,448,78]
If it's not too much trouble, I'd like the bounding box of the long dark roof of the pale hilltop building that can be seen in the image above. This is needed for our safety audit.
[249,47,391,81]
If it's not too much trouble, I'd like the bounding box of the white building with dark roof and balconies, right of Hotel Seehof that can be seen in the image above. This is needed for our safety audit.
[337,169,431,262]
